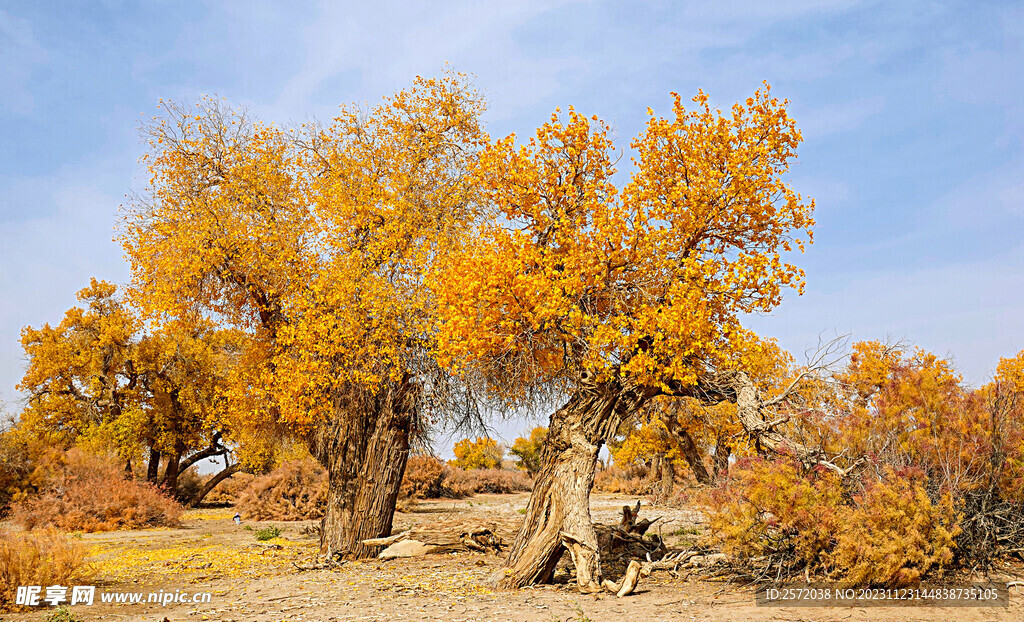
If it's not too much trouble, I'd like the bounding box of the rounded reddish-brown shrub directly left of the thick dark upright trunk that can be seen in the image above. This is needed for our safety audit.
[237,459,327,521]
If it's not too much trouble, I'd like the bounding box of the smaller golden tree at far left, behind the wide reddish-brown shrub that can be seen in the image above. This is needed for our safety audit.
[19,279,246,503]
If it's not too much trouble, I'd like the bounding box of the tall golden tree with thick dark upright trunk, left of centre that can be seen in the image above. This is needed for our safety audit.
[123,74,486,557]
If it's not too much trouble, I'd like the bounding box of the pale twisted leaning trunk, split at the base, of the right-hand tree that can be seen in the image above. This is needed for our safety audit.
[494,383,648,592]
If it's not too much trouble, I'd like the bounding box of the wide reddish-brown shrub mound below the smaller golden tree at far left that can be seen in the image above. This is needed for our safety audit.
[11,449,182,532]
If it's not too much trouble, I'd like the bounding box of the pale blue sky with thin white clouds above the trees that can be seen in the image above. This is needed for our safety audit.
[0,0,1024,446]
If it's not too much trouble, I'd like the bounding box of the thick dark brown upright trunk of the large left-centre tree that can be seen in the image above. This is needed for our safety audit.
[310,383,416,558]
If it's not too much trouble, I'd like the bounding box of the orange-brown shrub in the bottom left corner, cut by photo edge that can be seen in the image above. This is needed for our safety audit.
[0,529,91,612]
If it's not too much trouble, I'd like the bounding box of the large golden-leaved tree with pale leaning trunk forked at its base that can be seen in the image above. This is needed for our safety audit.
[437,87,813,591]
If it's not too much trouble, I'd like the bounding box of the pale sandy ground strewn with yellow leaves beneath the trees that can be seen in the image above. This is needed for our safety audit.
[0,494,1024,622]
